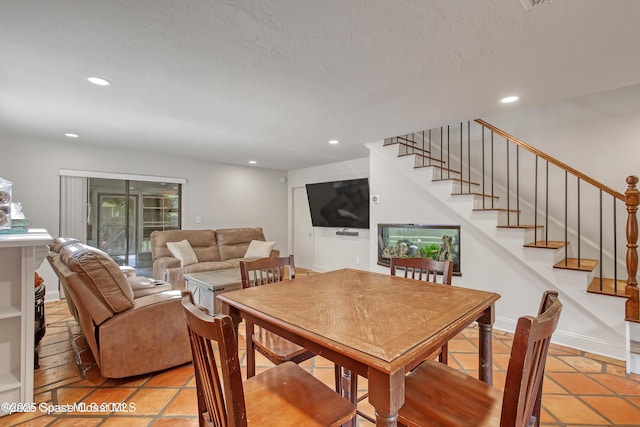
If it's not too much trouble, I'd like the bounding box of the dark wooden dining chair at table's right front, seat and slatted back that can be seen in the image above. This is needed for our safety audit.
[398,291,562,427]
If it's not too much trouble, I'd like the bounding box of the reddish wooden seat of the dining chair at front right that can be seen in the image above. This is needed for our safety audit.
[398,360,502,427]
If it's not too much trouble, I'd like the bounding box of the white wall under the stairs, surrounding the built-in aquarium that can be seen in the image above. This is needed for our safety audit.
[367,141,628,359]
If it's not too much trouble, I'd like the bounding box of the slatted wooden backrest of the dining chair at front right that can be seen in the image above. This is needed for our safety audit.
[500,291,562,427]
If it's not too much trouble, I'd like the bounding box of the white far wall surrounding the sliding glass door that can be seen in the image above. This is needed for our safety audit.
[0,135,287,300]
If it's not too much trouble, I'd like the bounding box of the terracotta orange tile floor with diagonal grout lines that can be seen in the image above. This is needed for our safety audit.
[0,301,640,427]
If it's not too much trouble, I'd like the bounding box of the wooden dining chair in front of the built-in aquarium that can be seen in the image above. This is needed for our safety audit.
[390,257,453,364]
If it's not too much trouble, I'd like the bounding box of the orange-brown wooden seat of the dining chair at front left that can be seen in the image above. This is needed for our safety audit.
[243,362,355,427]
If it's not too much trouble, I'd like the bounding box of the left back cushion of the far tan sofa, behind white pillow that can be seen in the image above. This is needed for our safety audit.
[151,230,219,262]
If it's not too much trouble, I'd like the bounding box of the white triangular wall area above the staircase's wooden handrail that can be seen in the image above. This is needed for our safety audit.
[483,85,640,193]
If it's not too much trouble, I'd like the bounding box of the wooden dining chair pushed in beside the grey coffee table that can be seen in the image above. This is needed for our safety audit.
[240,255,315,378]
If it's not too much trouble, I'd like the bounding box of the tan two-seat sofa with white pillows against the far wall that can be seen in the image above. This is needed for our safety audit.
[151,227,280,289]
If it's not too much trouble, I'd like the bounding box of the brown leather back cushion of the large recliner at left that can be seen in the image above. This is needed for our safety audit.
[61,245,133,313]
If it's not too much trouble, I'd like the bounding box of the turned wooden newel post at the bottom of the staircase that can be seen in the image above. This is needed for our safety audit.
[624,175,640,322]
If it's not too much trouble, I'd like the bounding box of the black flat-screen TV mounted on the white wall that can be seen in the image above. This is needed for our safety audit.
[306,178,369,228]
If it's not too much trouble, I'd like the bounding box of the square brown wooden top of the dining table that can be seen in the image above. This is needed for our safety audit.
[218,269,500,373]
